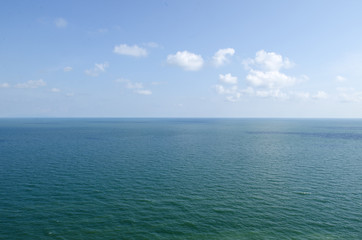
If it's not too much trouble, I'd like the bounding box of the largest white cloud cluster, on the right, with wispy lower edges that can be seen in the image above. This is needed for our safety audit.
[214,50,328,102]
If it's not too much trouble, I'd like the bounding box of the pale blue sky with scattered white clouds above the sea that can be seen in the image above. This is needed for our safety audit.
[0,0,362,118]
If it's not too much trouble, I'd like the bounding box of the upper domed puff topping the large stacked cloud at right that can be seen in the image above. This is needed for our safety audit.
[243,50,294,71]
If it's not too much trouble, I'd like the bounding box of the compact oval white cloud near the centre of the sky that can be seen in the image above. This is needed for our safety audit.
[167,51,204,71]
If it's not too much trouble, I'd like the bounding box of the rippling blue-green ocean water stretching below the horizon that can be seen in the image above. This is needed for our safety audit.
[0,119,362,239]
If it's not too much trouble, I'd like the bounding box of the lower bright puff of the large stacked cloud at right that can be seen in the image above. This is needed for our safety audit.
[246,69,296,89]
